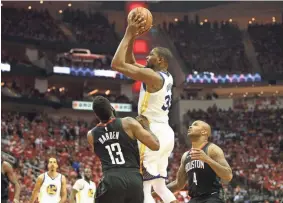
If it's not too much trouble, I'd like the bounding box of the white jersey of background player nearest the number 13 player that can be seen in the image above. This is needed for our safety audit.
[75,179,96,203]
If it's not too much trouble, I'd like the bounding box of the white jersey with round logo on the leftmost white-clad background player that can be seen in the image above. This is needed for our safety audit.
[38,172,62,203]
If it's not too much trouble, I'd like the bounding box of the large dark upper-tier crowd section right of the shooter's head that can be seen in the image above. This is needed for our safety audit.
[163,20,251,73]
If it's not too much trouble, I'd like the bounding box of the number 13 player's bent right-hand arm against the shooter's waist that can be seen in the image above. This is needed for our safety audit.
[123,117,160,151]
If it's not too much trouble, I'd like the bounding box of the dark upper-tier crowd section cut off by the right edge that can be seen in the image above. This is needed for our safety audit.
[248,23,283,73]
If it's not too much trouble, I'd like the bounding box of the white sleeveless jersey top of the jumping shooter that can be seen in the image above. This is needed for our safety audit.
[138,72,173,123]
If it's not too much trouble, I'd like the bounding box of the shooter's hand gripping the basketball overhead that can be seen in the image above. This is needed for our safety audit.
[126,14,146,37]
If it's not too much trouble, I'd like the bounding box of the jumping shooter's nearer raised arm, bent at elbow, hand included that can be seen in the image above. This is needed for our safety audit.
[111,15,163,86]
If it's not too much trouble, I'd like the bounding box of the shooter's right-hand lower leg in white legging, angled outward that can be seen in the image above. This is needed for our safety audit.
[152,178,177,203]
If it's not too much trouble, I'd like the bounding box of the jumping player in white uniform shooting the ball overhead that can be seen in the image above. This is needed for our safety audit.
[111,14,176,203]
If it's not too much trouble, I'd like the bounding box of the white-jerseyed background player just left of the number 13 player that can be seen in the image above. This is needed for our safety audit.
[70,168,96,203]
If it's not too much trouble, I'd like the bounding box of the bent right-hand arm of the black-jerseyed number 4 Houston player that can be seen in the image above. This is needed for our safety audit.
[207,145,233,181]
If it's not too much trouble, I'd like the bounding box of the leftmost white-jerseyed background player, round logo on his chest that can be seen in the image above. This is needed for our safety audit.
[30,158,67,203]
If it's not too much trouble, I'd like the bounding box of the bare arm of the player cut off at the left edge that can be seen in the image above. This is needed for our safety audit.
[3,161,21,203]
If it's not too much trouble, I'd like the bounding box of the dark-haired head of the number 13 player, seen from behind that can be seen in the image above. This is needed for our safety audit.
[92,96,113,121]
